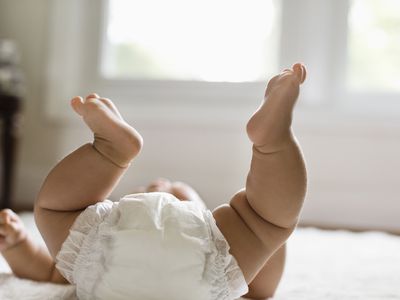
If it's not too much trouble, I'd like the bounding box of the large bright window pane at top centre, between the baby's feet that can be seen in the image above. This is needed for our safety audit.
[102,0,279,82]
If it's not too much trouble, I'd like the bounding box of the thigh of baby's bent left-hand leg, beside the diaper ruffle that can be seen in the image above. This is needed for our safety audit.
[35,206,82,258]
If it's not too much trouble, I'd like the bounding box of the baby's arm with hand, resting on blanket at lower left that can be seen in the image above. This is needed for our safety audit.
[0,209,66,283]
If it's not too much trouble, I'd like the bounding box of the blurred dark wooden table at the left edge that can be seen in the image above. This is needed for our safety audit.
[0,94,21,209]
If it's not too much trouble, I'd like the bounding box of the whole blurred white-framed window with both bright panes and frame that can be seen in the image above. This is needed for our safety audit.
[47,0,400,122]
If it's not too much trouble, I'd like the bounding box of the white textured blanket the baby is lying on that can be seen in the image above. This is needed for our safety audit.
[0,214,400,300]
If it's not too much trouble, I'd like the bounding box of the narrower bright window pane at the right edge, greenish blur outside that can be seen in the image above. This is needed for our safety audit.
[348,0,400,91]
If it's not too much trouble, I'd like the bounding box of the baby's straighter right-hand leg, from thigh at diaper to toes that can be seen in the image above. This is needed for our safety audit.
[213,64,306,297]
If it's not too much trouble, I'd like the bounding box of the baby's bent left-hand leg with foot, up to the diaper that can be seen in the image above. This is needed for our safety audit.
[35,94,142,256]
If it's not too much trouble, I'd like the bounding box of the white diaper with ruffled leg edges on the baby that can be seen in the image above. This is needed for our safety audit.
[56,193,248,300]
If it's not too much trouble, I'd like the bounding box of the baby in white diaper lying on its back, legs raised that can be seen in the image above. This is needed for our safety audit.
[0,64,306,300]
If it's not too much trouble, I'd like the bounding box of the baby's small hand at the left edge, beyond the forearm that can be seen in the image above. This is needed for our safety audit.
[0,209,27,251]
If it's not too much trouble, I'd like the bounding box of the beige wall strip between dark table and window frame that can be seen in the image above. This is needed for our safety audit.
[0,0,61,203]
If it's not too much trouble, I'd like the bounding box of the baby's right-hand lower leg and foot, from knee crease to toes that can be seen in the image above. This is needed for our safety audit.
[246,64,306,228]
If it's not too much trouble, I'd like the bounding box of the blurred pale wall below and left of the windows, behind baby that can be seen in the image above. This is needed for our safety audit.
[0,0,400,231]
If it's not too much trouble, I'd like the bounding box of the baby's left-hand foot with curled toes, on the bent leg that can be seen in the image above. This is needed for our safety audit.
[71,94,143,168]
